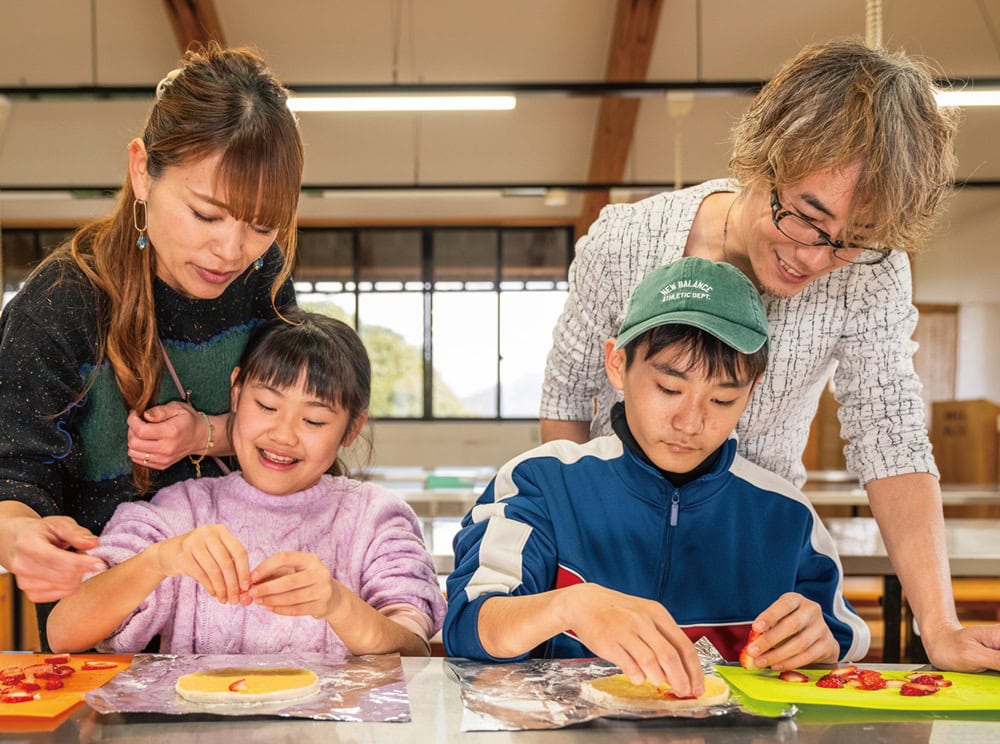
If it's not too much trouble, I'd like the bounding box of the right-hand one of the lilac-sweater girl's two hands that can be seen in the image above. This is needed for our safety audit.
[250,551,348,620]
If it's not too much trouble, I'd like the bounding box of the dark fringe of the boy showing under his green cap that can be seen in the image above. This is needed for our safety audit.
[625,324,767,385]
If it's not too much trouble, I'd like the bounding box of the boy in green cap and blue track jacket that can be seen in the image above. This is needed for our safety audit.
[444,257,870,695]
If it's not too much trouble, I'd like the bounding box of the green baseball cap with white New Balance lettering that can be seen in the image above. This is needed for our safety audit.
[615,256,767,354]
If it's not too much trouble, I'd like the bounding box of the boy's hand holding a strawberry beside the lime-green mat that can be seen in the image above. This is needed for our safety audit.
[747,592,840,671]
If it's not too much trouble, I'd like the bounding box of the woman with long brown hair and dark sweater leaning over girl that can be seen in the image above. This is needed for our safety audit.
[0,45,302,645]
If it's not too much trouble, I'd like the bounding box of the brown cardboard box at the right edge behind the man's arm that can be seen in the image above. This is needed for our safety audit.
[931,400,1000,483]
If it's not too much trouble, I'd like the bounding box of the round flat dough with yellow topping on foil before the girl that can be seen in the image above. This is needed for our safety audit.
[174,667,319,704]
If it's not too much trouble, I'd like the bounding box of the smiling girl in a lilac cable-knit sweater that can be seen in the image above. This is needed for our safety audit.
[48,310,444,655]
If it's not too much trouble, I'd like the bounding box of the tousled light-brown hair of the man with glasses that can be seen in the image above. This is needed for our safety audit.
[729,39,959,252]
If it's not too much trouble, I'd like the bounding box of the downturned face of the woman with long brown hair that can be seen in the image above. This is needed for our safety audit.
[129,140,277,300]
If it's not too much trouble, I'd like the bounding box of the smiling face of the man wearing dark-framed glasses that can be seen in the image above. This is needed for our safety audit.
[746,164,861,297]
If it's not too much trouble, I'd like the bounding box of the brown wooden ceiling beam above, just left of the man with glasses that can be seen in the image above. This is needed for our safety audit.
[576,0,663,237]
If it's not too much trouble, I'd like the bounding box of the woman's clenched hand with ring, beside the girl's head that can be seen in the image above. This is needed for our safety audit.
[127,401,207,470]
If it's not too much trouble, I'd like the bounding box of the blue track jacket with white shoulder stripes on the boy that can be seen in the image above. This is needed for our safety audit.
[444,435,870,661]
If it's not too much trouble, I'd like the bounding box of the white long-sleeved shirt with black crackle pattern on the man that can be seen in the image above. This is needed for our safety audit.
[540,180,938,486]
